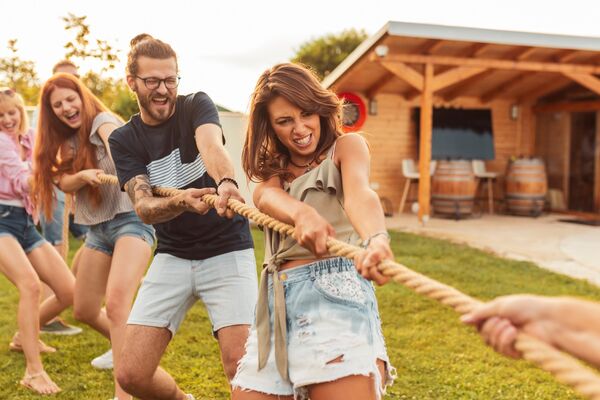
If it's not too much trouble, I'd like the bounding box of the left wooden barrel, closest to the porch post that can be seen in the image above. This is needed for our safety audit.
[431,160,476,218]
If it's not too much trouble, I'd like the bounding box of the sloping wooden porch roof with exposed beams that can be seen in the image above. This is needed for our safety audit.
[323,21,600,103]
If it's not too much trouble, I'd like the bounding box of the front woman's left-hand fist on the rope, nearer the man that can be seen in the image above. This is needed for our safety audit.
[294,206,335,257]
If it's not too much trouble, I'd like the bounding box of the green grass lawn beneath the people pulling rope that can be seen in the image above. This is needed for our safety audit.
[0,231,600,400]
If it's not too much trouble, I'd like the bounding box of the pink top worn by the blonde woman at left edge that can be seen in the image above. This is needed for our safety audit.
[0,129,33,214]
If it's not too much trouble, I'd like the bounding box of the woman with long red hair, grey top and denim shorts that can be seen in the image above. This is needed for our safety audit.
[33,73,154,400]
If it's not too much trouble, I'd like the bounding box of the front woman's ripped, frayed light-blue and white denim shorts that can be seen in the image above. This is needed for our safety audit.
[231,258,394,399]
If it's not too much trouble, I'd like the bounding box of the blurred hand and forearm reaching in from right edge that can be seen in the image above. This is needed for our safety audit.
[462,295,600,366]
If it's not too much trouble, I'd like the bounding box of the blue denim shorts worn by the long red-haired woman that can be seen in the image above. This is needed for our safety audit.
[85,211,155,256]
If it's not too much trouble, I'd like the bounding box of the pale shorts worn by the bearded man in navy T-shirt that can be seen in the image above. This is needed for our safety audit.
[127,249,258,335]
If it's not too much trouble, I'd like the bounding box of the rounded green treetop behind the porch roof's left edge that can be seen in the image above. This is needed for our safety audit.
[292,29,368,79]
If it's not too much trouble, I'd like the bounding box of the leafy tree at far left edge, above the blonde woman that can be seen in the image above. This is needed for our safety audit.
[0,39,40,104]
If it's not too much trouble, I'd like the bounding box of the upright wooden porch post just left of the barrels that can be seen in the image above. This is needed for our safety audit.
[419,63,433,224]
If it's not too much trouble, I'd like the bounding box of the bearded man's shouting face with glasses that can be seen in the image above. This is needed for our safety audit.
[127,56,177,125]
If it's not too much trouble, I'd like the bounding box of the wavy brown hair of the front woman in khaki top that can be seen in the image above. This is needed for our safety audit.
[242,63,342,182]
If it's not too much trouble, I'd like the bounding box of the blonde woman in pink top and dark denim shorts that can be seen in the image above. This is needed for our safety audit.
[0,88,75,394]
